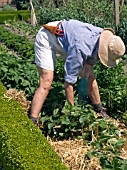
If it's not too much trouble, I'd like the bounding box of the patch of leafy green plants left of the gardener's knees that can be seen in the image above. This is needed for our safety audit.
[0,53,38,99]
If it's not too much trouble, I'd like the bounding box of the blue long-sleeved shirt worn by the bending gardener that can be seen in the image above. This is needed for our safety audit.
[57,19,103,84]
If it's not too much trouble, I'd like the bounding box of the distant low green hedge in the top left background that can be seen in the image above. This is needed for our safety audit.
[0,10,30,24]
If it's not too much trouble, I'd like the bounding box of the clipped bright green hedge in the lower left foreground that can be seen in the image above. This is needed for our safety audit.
[0,82,68,170]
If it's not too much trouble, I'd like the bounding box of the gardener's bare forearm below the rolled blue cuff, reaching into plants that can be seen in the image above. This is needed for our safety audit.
[64,81,74,106]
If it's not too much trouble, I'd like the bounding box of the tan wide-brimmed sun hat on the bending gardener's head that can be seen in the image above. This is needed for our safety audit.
[98,28,125,67]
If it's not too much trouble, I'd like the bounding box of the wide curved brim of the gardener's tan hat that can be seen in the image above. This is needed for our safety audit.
[98,28,120,68]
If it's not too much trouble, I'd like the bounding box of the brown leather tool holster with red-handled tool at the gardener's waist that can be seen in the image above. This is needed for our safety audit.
[43,22,64,36]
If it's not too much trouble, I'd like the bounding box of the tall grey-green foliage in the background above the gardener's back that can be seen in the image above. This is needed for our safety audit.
[35,0,127,49]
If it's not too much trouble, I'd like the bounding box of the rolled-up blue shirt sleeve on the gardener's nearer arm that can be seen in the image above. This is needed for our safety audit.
[64,46,83,84]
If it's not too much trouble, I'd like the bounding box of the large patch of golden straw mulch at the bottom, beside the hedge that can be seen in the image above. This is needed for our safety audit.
[48,138,102,170]
